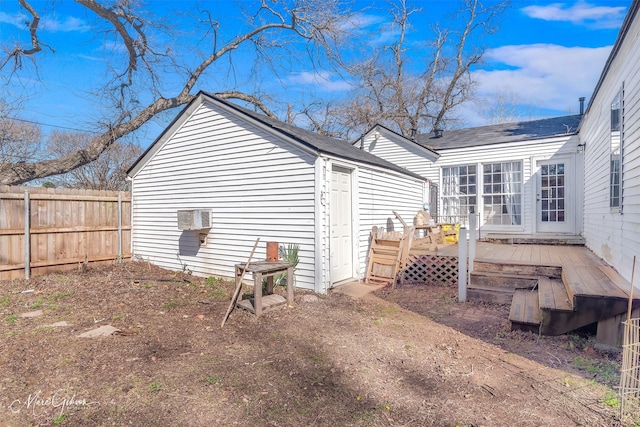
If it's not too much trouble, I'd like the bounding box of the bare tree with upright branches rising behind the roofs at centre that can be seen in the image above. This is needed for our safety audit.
[312,0,507,138]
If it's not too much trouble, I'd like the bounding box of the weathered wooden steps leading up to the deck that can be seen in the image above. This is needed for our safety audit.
[467,260,628,335]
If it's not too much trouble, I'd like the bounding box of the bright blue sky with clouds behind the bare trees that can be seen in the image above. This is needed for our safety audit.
[0,0,631,147]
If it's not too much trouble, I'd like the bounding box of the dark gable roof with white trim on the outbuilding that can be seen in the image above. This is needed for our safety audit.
[127,91,426,180]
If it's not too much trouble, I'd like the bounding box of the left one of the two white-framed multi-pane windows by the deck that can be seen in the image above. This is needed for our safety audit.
[442,165,478,222]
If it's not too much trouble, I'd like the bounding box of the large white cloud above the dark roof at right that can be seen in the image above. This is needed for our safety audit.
[473,44,611,113]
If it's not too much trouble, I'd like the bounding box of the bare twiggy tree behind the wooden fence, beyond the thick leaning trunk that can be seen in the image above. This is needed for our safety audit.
[47,132,142,191]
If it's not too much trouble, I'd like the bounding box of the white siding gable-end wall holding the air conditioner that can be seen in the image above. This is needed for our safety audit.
[132,102,317,289]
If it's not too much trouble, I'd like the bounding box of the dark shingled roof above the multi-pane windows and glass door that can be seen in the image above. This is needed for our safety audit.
[416,114,582,150]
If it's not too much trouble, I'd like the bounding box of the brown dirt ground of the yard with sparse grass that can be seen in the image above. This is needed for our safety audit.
[0,262,640,427]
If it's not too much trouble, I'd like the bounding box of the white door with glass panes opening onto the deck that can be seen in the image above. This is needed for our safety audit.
[536,160,573,233]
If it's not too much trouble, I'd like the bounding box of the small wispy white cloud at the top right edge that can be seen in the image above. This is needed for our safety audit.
[522,0,626,28]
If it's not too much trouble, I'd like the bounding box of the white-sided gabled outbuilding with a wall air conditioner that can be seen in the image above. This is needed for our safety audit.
[128,92,429,293]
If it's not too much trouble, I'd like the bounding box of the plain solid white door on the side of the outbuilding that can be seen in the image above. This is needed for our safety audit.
[331,167,353,283]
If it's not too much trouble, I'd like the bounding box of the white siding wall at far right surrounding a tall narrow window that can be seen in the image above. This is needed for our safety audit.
[580,6,640,280]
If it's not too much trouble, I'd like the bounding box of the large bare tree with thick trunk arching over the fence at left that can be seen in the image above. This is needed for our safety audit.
[0,0,347,184]
